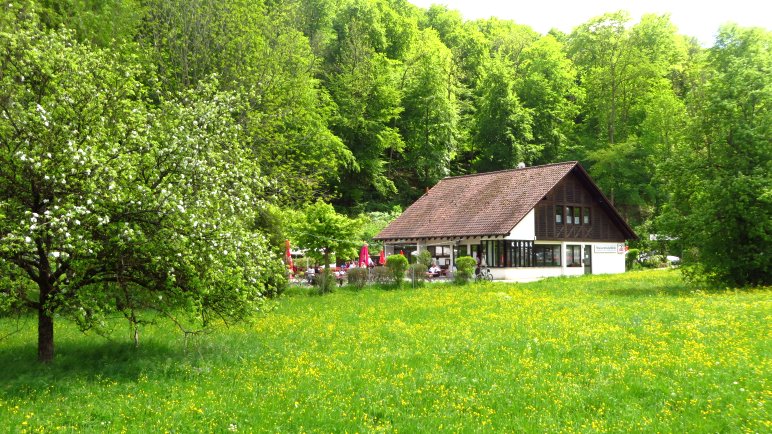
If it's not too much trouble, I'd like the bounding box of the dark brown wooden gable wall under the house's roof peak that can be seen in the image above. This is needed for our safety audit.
[534,172,625,242]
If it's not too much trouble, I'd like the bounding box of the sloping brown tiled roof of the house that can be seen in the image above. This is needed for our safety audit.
[375,161,584,240]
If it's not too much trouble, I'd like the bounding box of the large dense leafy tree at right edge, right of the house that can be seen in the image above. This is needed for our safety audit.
[660,26,772,285]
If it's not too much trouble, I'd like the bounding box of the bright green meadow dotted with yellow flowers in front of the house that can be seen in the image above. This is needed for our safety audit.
[0,270,772,432]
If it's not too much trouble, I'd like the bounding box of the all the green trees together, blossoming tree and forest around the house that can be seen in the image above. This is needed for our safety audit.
[0,0,772,360]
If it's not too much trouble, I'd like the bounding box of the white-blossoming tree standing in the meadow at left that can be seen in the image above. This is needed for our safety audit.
[0,20,281,361]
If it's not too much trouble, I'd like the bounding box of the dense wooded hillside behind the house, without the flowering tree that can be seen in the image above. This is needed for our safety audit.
[24,0,769,219]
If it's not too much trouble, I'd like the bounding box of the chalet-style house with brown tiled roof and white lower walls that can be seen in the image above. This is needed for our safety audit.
[375,161,637,280]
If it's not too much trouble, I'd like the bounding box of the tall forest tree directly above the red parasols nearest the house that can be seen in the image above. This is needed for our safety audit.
[325,0,404,208]
